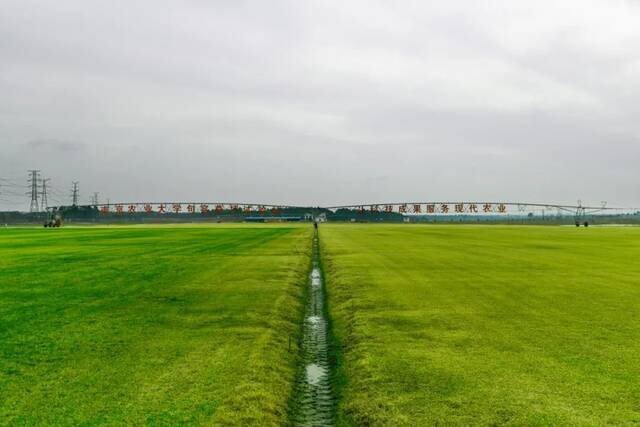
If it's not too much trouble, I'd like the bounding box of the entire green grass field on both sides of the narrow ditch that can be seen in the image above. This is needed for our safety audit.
[0,224,640,426]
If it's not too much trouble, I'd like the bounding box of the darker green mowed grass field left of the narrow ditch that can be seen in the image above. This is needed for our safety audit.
[0,225,312,425]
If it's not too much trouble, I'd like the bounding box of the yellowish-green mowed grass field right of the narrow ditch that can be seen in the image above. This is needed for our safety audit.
[320,225,640,426]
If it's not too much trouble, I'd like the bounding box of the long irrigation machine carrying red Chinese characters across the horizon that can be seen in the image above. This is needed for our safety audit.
[45,201,634,227]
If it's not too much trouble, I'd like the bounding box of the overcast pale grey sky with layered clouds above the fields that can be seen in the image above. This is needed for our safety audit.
[0,0,640,209]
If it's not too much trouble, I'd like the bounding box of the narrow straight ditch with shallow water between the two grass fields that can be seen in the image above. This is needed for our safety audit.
[292,232,334,426]
